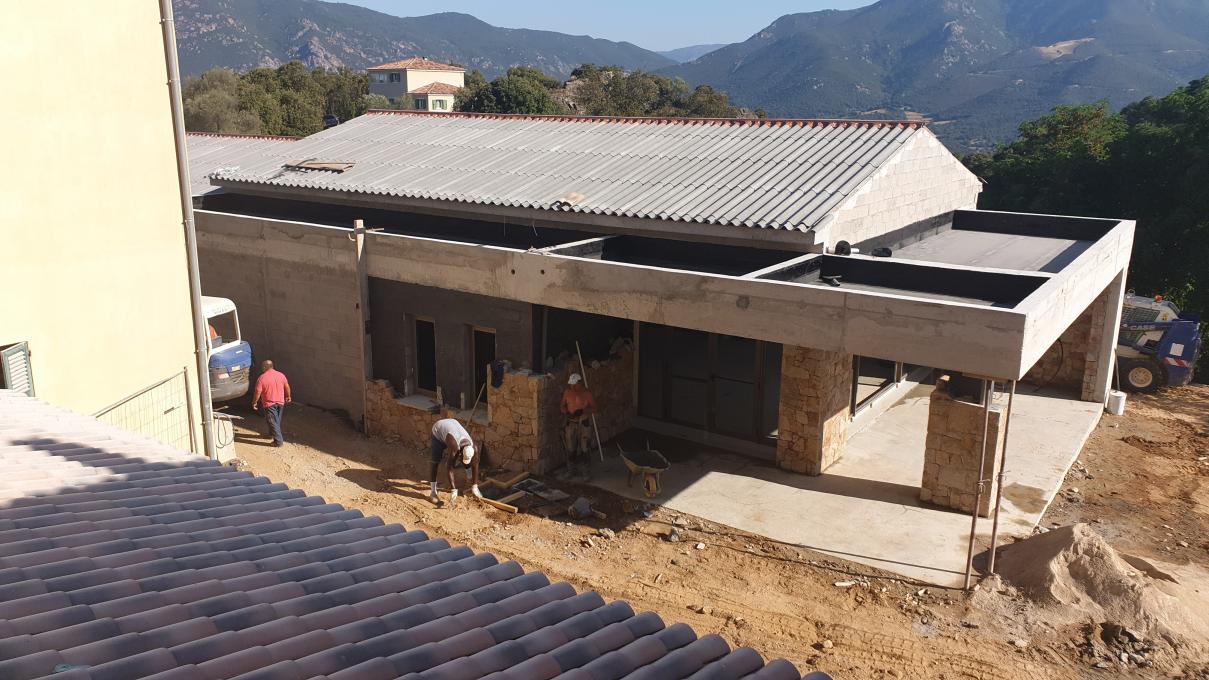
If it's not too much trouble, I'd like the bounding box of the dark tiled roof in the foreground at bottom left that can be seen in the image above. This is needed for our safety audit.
[0,391,799,680]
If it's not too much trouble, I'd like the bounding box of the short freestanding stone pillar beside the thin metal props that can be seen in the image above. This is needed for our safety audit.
[919,375,1002,517]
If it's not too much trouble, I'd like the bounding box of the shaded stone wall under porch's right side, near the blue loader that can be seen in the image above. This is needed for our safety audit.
[1020,284,1109,400]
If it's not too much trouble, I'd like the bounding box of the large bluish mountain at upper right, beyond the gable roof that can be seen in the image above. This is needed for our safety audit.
[660,0,1209,150]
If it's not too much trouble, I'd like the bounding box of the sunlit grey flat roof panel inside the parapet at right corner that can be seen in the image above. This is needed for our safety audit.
[893,229,1093,273]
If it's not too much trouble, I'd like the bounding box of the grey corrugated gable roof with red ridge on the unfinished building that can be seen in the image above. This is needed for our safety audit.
[215,111,922,231]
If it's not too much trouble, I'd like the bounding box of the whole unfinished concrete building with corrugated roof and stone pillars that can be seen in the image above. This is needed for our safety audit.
[197,111,1134,583]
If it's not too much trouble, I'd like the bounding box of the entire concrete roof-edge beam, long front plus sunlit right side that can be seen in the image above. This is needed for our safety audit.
[197,211,1133,379]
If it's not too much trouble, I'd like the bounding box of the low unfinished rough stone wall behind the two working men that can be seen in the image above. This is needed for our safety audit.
[366,350,636,473]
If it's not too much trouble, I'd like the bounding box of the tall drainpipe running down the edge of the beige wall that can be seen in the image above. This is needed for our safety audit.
[160,0,216,460]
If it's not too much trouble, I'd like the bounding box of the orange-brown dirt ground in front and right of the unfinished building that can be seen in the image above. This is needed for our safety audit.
[220,386,1209,680]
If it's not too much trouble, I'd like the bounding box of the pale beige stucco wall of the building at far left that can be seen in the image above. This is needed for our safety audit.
[0,2,199,440]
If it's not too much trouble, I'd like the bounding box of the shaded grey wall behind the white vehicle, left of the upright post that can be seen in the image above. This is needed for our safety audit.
[197,213,365,422]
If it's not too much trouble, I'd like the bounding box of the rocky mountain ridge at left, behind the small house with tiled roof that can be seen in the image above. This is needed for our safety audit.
[173,0,676,77]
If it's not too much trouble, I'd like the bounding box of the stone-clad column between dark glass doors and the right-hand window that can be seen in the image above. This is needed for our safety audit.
[776,345,852,476]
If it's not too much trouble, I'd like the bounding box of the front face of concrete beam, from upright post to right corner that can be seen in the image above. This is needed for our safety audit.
[357,221,1024,374]
